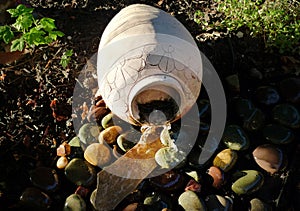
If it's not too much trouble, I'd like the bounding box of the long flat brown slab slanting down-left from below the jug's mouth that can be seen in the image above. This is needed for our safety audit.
[95,127,163,211]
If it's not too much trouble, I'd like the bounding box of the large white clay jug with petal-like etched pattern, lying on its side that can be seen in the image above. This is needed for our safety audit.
[97,4,202,125]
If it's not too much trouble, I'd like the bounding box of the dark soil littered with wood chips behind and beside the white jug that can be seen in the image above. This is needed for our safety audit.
[0,0,300,210]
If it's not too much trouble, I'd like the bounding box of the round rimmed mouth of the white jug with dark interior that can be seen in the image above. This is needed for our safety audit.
[128,74,185,125]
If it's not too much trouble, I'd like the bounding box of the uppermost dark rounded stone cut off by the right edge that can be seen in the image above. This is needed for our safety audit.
[279,78,300,104]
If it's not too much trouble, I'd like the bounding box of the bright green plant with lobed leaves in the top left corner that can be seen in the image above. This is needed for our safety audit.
[0,4,64,51]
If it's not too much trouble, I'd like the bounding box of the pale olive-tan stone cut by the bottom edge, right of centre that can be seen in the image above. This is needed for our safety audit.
[178,190,206,211]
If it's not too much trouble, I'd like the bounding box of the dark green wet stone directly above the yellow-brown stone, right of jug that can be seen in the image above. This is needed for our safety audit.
[222,125,250,150]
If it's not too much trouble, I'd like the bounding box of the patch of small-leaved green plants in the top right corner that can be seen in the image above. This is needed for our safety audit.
[195,0,300,53]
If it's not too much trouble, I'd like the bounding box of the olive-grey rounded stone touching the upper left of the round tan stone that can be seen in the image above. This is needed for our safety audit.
[78,123,101,150]
